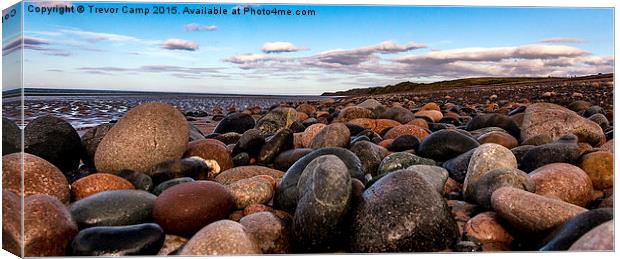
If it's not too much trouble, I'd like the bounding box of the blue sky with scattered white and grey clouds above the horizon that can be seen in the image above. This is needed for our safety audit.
[3,2,614,95]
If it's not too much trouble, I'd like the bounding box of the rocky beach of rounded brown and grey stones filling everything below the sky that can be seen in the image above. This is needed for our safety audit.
[2,75,614,256]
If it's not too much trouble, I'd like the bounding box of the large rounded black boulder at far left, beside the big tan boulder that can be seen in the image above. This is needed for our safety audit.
[24,115,82,172]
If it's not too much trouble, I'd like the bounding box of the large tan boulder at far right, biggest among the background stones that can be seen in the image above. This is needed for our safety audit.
[521,103,605,147]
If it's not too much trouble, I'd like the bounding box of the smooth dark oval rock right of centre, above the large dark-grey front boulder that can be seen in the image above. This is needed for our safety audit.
[417,130,480,161]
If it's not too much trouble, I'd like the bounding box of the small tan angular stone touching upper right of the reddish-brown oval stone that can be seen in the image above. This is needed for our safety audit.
[228,175,275,210]
